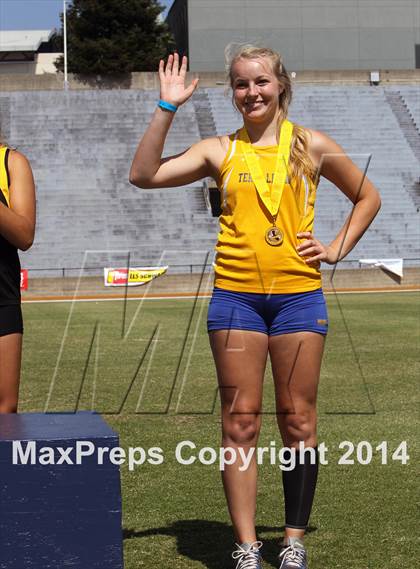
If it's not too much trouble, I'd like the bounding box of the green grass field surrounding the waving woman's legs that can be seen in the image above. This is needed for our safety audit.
[20,293,420,569]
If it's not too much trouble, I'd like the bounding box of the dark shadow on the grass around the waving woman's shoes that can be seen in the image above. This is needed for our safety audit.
[123,520,317,569]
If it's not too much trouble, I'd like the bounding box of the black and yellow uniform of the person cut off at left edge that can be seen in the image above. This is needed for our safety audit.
[0,146,23,335]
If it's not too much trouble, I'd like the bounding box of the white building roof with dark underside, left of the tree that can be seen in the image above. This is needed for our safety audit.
[0,30,55,61]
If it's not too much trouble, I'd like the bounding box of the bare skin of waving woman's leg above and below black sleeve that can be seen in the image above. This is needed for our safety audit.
[269,332,325,538]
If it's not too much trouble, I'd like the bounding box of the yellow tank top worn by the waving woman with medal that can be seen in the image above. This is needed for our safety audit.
[214,123,321,294]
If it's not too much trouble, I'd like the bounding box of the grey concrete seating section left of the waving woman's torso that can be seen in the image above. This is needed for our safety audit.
[3,90,216,270]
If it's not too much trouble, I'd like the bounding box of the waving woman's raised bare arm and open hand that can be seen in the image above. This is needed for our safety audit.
[129,54,214,188]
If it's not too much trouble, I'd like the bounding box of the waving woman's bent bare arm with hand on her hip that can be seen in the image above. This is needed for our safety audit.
[298,131,381,264]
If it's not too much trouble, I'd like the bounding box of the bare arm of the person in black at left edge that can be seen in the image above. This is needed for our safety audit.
[0,151,35,251]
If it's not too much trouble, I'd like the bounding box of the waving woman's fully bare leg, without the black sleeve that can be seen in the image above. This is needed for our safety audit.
[210,330,268,544]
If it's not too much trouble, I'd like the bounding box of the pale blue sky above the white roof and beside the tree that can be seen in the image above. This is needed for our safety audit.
[0,0,173,30]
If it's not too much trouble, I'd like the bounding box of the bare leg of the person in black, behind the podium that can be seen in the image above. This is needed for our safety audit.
[0,334,22,413]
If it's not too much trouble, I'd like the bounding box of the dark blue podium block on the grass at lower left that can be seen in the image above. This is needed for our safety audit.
[0,411,123,569]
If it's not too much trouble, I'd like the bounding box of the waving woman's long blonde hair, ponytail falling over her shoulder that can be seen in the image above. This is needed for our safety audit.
[225,44,316,186]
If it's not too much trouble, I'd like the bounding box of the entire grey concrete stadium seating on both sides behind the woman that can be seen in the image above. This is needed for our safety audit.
[0,85,420,278]
